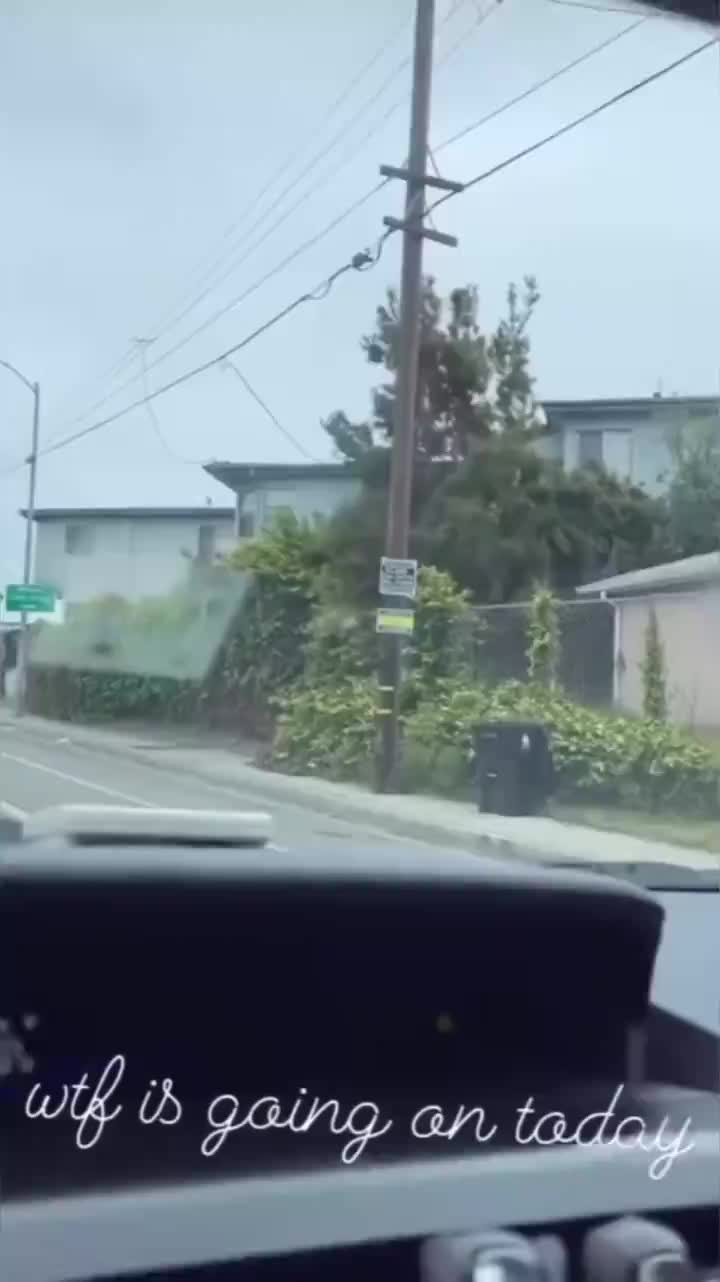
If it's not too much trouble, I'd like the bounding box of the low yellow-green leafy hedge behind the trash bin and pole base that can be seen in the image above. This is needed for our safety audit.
[272,679,719,815]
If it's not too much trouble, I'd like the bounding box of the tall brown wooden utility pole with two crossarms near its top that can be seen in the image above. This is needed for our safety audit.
[375,0,462,792]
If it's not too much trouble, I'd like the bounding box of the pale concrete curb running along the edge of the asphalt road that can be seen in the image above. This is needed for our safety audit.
[0,717,515,856]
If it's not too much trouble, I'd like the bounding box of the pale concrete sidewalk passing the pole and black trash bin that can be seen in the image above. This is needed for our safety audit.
[0,709,717,868]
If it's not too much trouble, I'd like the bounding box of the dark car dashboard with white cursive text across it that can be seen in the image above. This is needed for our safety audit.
[0,817,720,1282]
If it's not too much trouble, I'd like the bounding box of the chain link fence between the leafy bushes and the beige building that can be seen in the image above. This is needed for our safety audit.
[448,601,615,708]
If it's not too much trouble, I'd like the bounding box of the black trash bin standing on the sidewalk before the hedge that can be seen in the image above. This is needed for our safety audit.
[475,720,555,815]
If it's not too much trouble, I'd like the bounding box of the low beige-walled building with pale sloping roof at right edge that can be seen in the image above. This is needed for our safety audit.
[577,551,720,729]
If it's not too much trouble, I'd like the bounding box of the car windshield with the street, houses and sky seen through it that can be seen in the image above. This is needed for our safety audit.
[0,0,720,868]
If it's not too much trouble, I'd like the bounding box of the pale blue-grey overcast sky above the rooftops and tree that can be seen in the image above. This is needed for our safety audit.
[0,0,720,579]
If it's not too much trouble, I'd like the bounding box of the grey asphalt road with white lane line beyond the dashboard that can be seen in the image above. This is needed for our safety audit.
[0,724,427,849]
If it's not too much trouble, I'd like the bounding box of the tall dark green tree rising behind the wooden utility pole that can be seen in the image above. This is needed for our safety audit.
[319,277,666,605]
